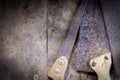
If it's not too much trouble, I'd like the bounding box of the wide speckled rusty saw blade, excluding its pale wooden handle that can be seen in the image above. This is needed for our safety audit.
[76,0,110,72]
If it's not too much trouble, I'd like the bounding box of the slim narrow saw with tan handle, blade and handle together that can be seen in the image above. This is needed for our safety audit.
[48,0,88,80]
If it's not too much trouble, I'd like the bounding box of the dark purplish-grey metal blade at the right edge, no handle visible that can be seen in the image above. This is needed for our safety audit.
[101,0,120,76]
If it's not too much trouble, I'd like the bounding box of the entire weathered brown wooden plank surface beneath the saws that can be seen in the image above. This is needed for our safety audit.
[0,0,96,80]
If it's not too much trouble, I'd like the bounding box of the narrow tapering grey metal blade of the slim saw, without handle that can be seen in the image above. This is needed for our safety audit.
[58,0,88,59]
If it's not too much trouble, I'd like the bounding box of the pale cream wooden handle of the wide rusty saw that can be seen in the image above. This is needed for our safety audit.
[90,52,112,80]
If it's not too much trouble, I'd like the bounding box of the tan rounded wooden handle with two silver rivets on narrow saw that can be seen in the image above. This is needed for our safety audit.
[48,56,68,80]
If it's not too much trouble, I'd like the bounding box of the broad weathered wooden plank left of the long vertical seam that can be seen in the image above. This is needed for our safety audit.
[0,0,47,80]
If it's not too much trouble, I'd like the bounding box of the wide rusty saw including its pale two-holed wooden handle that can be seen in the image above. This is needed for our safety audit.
[76,0,111,80]
